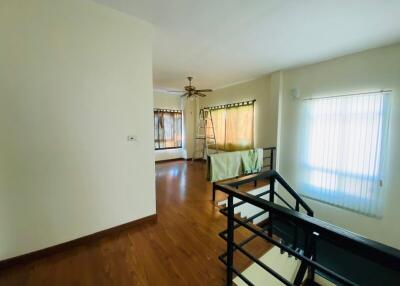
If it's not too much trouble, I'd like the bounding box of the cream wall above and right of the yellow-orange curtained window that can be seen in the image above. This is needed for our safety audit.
[199,73,279,147]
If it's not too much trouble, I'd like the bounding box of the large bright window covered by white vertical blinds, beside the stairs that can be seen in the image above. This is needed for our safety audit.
[300,93,388,216]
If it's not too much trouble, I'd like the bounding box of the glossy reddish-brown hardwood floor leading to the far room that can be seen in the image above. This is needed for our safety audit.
[0,161,270,286]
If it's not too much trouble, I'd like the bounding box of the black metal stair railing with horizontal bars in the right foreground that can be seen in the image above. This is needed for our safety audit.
[216,177,400,285]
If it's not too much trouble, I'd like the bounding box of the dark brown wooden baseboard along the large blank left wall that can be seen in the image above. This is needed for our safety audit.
[0,214,157,271]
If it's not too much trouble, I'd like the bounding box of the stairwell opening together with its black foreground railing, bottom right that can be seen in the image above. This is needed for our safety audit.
[215,170,400,286]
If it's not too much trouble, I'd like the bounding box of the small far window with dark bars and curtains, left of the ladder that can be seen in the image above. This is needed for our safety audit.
[154,109,182,150]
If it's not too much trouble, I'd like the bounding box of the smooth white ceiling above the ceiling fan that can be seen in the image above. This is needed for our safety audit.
[95,0,400,89]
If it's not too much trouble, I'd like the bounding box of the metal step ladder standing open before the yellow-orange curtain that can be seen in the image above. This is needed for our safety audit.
[192,109,218,163]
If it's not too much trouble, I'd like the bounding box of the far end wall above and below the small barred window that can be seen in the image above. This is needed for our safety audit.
[153,90,184,161]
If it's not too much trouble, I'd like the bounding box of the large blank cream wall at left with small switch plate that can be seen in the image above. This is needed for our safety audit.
[0,0,156,260]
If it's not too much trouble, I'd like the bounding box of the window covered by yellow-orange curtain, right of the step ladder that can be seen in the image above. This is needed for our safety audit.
[207,101,254,151]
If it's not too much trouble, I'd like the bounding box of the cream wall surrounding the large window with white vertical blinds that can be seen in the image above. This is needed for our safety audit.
[278,45,400,248]
